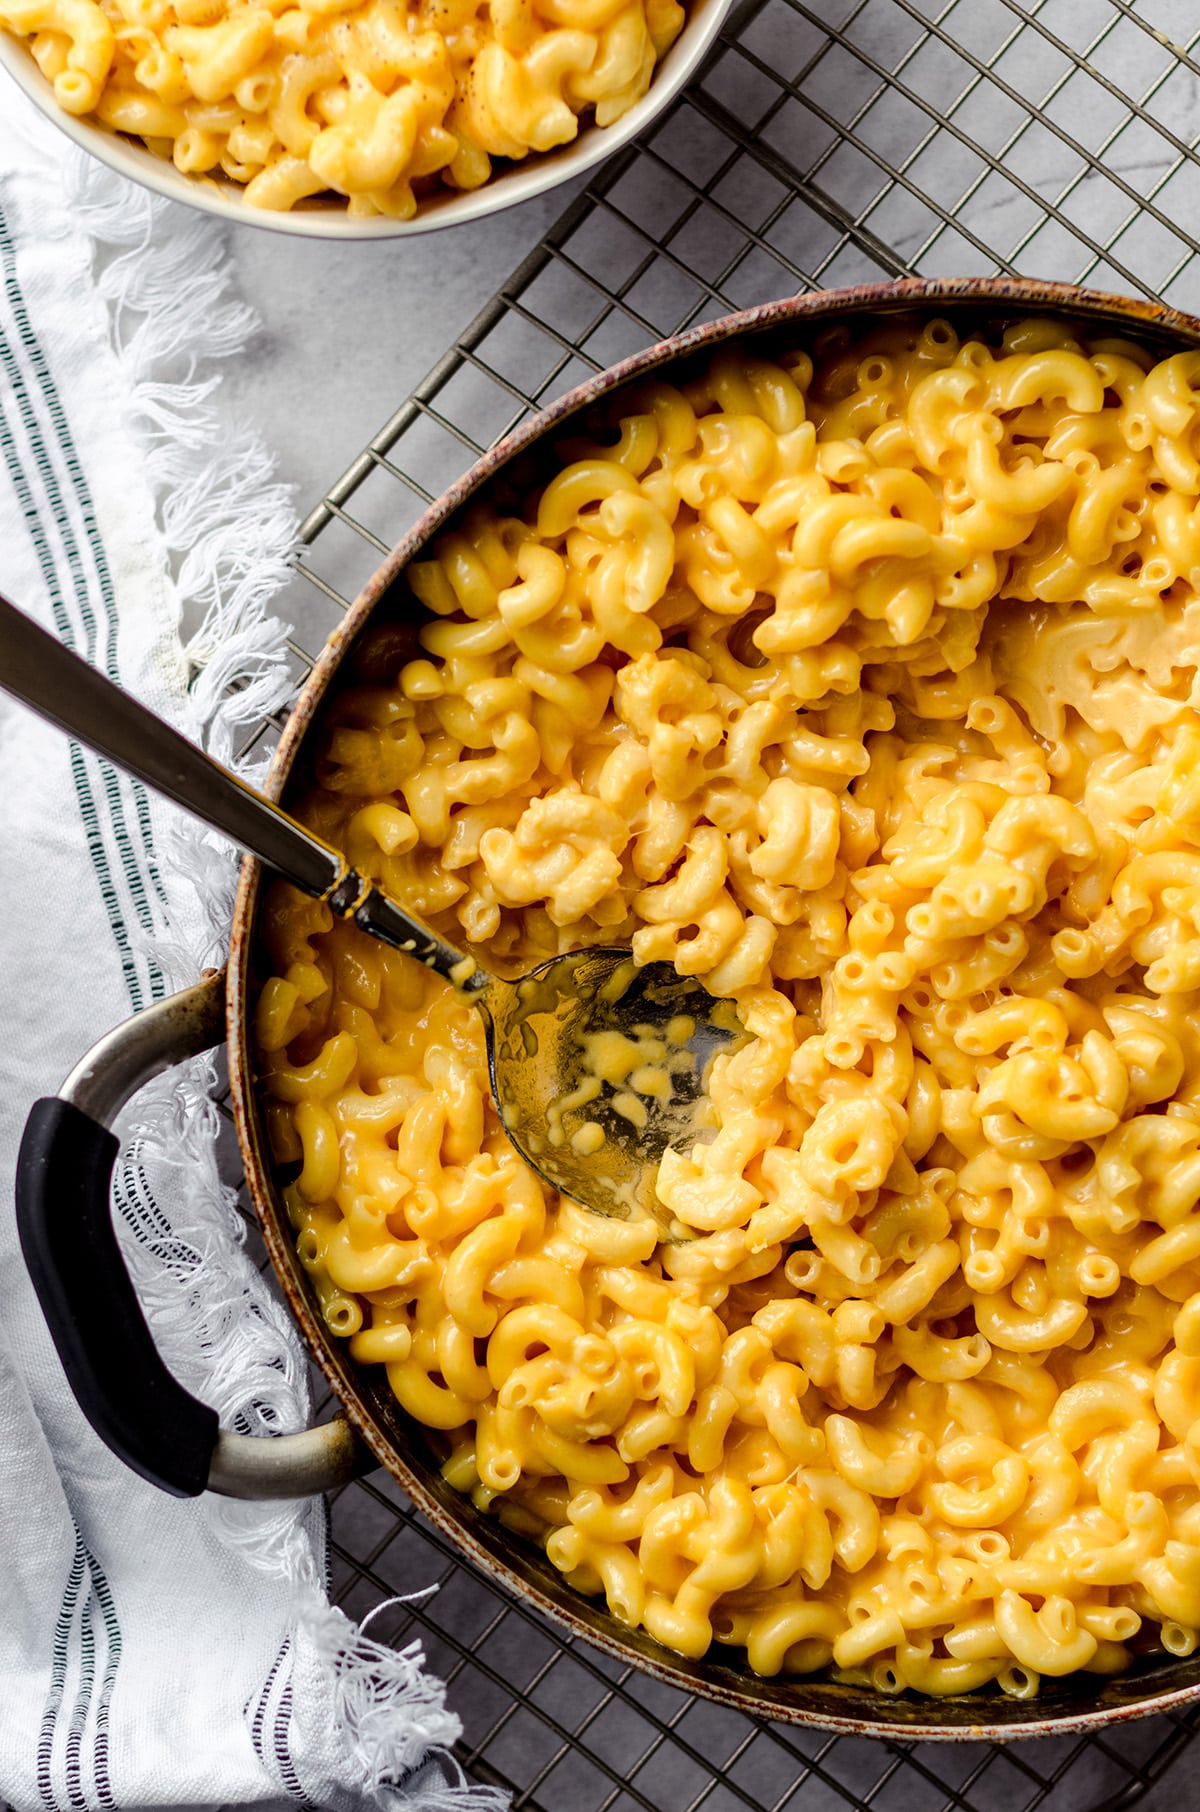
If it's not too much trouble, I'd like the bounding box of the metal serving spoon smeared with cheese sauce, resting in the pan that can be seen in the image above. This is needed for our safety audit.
[0,594,745,1236]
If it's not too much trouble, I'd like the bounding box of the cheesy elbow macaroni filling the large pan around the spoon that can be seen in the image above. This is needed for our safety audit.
[256,319,1200,1696]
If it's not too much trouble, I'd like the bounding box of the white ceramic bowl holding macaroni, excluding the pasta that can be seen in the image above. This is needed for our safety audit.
[0,0,734,239]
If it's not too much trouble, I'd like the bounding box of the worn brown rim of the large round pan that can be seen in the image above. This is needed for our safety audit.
[227,277,1200,1743]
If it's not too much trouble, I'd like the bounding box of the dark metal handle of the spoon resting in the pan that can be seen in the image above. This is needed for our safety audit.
[0,593,488,991]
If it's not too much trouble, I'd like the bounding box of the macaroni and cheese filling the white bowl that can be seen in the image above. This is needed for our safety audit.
[0,0,683,219]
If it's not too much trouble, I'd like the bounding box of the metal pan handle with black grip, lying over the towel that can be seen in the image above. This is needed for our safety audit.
[16,975,373,1499]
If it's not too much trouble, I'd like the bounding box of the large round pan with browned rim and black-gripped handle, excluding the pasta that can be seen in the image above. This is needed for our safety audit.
[18,279,1200,1741]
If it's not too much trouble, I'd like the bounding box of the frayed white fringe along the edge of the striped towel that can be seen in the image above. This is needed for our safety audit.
[57,152,509,1812]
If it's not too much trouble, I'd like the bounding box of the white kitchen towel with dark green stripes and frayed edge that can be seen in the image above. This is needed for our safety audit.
[0,74,504,1812]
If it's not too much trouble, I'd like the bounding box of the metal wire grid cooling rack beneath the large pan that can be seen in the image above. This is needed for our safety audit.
[237,0,1200,1812]
